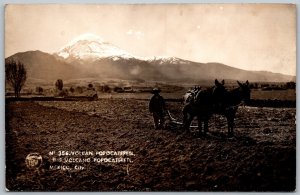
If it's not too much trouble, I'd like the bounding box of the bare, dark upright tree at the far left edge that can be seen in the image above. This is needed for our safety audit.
[5,59,27,97]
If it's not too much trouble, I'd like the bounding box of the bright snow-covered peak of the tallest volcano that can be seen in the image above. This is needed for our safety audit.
[56,34,133,60]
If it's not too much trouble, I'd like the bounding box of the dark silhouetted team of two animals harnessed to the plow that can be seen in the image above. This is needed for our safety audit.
[183,79,251,137]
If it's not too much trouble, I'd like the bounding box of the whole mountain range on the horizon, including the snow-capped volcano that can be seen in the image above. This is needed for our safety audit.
[8,34,295,82]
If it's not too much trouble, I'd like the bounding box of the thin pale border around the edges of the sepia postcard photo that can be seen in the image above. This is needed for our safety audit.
[0,0,300,195]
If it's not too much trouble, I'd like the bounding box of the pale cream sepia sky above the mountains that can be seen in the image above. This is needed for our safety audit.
[5,4,296,75]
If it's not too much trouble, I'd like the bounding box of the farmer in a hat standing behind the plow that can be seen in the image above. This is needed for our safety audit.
[149,88,166,129]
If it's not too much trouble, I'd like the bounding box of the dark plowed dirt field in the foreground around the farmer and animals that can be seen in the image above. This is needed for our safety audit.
[6,99,296,191]
